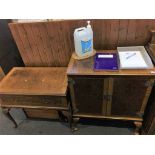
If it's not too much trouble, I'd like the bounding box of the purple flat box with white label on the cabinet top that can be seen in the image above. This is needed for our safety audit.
[94,52,119,71]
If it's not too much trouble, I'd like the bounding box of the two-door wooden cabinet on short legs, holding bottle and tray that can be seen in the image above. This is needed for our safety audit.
[67,51,155,134]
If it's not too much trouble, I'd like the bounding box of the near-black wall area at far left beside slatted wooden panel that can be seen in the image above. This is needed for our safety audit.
[0,19,24,74]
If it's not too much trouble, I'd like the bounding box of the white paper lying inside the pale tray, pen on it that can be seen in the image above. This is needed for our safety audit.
[118,51,147,68]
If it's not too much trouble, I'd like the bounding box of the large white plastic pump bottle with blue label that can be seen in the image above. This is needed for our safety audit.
[74,21,93,57]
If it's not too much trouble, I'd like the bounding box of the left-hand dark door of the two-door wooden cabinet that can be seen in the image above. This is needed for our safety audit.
[74,78,106,115]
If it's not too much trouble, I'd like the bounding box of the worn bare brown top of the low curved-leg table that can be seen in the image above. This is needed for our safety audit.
[0,67,67,96]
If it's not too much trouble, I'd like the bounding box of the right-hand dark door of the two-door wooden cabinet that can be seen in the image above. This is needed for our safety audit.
[111,77,152,117]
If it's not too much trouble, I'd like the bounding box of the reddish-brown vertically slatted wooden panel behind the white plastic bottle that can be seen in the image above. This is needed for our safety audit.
[10,19,155,66]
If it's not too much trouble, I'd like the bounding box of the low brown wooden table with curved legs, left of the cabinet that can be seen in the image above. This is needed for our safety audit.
[0,67,71,127]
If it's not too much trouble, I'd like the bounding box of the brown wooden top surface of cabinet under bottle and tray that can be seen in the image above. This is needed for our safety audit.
[67,50,155,77]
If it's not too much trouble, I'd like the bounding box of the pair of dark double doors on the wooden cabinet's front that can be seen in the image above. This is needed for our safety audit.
[72,77,152,118]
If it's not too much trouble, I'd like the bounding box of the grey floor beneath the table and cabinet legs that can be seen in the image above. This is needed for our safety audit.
[0,109,133,135]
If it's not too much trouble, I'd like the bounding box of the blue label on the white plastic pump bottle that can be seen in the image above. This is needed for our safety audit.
[81,39,92,53]
